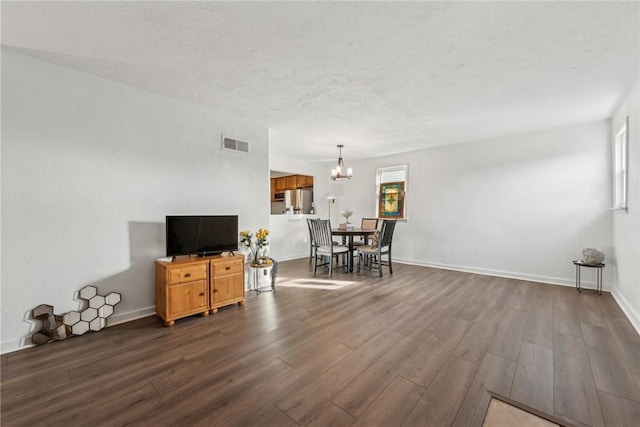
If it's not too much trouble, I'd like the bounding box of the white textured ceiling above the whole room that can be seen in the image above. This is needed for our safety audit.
[2,1,640,160]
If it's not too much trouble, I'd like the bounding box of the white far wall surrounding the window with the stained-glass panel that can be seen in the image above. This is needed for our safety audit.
[336,121,613,288]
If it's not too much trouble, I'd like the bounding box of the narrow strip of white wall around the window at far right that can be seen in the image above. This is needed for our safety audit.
[611,80,640,333]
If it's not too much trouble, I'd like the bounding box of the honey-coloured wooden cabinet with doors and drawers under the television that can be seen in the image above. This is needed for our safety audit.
[156,254,245,326]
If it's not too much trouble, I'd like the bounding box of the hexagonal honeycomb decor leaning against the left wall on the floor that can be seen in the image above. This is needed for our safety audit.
[31,286,122,345]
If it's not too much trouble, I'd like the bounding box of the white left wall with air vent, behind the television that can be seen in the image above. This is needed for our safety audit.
[1,48,269,352]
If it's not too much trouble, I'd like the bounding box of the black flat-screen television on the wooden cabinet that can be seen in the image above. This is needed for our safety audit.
[166,215,238,256]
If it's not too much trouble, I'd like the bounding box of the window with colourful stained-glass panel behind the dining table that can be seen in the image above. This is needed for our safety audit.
[376,165,409,219]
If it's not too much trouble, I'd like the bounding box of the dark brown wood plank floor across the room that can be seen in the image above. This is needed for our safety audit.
[1,259,640,426]
